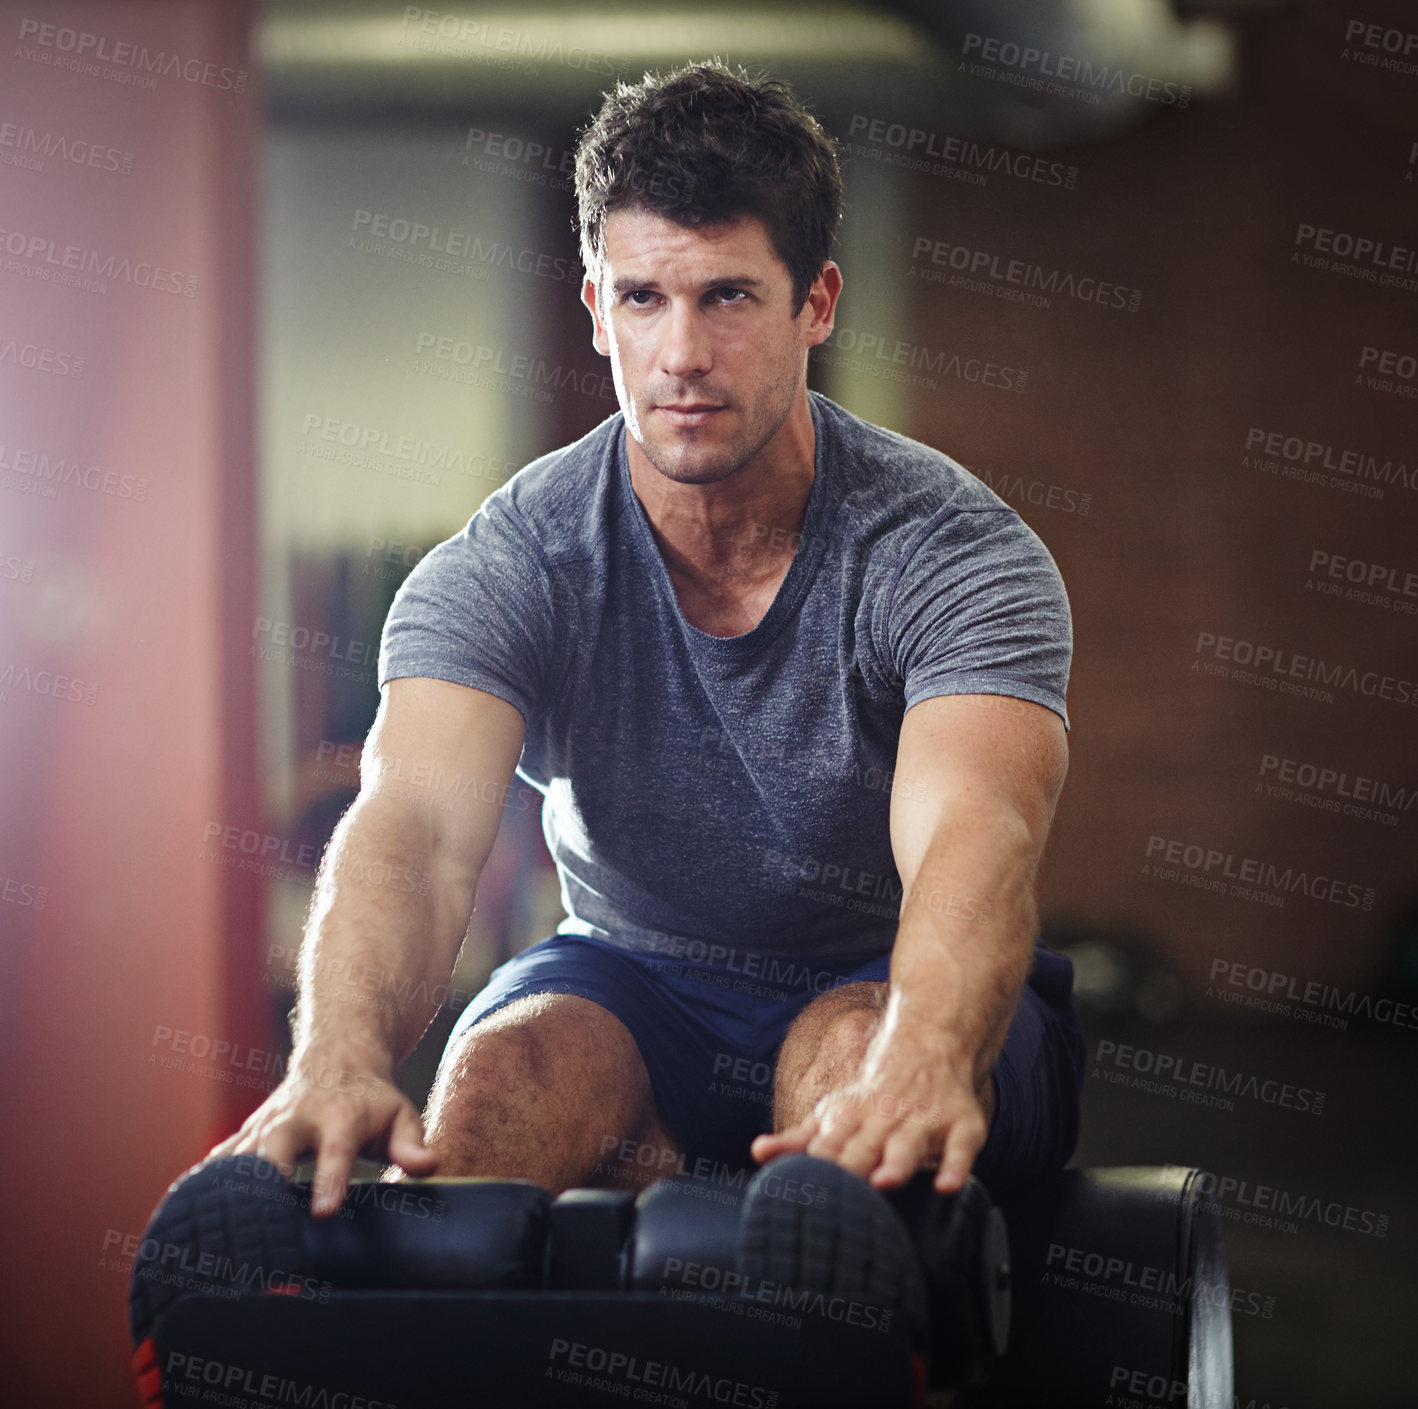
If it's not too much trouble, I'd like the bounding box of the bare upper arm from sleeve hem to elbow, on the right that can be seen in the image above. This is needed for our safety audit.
[891,695,1068,890]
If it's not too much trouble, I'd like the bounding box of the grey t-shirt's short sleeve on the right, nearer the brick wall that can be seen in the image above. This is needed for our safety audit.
[885,506,1073,729]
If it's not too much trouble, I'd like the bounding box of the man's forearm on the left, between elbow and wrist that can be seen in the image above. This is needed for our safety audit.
[294,794,478,1074]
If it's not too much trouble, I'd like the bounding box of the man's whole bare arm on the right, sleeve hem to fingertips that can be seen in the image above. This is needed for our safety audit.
[754,695,1068,1194]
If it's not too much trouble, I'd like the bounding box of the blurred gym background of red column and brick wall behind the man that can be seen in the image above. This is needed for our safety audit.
[0,0,1418,1409]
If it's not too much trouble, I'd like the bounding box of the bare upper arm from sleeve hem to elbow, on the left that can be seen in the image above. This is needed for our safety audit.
[360,676,526,873]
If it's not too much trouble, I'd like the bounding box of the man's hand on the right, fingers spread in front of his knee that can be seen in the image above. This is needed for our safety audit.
[752,1032,994,1194]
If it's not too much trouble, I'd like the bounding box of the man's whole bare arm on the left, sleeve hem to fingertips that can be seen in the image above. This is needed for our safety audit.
[213,679,523,1213]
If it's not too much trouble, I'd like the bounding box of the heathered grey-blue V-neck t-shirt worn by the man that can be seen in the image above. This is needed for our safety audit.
[379,393,1072,962]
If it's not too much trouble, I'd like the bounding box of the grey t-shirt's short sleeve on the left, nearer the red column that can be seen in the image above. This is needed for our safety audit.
[379,493,556,720]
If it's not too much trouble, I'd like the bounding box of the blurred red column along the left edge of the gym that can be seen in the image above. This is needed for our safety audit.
[0,0,260,1405]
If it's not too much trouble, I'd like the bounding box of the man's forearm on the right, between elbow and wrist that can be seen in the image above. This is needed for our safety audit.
[882,808,1038,1087]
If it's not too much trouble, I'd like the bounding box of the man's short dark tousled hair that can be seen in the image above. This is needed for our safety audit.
[576,61,842,312]
